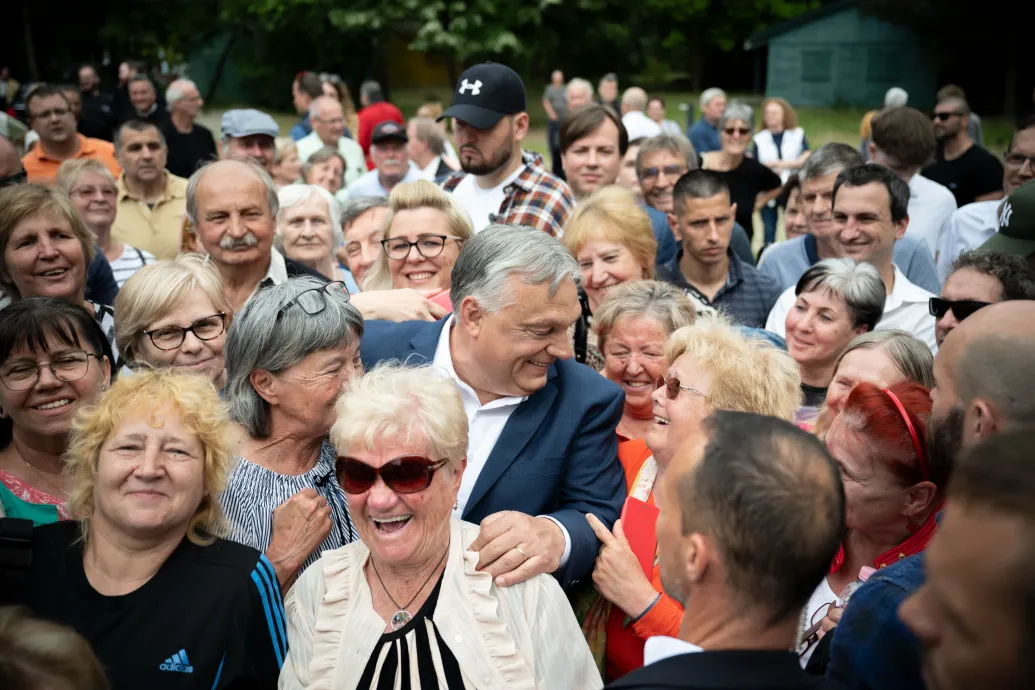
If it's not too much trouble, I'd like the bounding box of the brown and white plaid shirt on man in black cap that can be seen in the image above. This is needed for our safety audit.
[442,151,574,239]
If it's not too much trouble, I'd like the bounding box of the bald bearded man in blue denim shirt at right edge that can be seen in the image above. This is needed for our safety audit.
[827,300,1035,690]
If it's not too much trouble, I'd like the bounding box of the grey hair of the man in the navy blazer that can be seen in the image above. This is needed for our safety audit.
[450,224,582,321]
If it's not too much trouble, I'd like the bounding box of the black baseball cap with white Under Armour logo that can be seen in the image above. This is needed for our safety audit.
[438,62,525,129]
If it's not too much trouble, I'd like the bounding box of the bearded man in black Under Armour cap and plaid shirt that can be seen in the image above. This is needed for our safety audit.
[439,62,574,237]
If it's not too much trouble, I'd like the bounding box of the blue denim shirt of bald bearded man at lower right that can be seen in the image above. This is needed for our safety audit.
[827,552,924,690]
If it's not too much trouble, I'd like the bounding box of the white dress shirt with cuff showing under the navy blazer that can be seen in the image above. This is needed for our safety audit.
[432,317,571,568]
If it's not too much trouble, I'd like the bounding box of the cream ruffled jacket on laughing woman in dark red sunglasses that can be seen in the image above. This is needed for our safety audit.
[279,519,603,690]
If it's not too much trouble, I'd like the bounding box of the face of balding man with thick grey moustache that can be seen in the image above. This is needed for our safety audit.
[195,161,276,267]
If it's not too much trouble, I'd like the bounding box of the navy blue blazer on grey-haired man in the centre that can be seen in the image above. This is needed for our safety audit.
[360,319,626,587]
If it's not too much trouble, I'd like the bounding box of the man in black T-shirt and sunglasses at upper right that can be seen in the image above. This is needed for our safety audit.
[923,97,1003,207]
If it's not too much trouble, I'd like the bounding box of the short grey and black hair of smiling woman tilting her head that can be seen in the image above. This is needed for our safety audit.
[794,259,887,331]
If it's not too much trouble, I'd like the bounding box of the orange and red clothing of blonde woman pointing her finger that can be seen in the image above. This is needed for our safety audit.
[605,439,683,680]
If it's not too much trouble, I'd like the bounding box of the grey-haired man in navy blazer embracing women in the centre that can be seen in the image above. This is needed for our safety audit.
[360,226,626,587]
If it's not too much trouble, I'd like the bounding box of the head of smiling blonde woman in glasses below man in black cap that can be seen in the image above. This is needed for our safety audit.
[363,180,474,310]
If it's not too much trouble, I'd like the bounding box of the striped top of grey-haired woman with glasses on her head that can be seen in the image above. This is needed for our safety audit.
[219,441,359,573]
